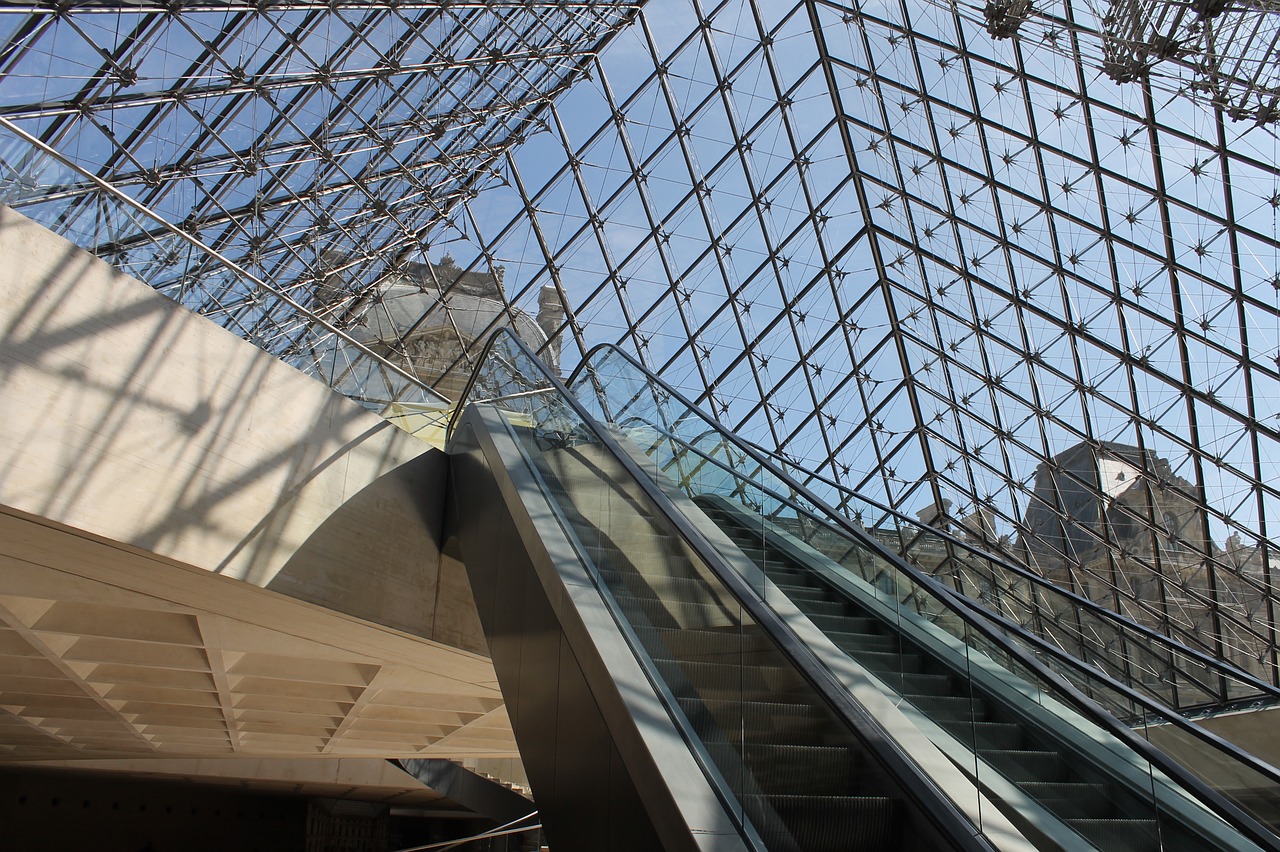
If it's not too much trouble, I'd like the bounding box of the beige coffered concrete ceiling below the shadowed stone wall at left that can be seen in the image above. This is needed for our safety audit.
[0,512,516,761]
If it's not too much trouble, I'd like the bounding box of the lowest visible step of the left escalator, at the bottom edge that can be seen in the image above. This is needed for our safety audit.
[744,796,900,852]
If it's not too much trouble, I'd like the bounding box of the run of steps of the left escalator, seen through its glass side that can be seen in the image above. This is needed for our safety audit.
[520,430,901,852]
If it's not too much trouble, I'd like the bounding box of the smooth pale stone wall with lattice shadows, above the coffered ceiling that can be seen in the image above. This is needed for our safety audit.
[0,209,484,650]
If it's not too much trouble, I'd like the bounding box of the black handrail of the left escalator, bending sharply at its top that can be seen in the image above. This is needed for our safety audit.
[449,327,996,852]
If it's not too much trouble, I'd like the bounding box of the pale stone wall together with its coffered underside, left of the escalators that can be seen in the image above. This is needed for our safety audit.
[0,207,504,761]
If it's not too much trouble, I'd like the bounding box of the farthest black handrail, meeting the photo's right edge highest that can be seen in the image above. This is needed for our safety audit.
[564,343,1280,706]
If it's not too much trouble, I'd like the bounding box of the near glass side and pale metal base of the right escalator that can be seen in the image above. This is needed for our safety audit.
[571,340,1280,852]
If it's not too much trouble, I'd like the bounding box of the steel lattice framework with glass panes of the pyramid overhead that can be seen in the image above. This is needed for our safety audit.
[0,0,1280,679]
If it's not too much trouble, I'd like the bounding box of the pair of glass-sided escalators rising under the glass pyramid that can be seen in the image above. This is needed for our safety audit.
[449,336,1280,852]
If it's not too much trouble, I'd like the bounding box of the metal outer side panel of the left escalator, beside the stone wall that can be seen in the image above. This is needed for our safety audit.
[447,412,745,852]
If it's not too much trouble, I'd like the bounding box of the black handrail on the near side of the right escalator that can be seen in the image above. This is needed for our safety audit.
[568,344,1280,852]
